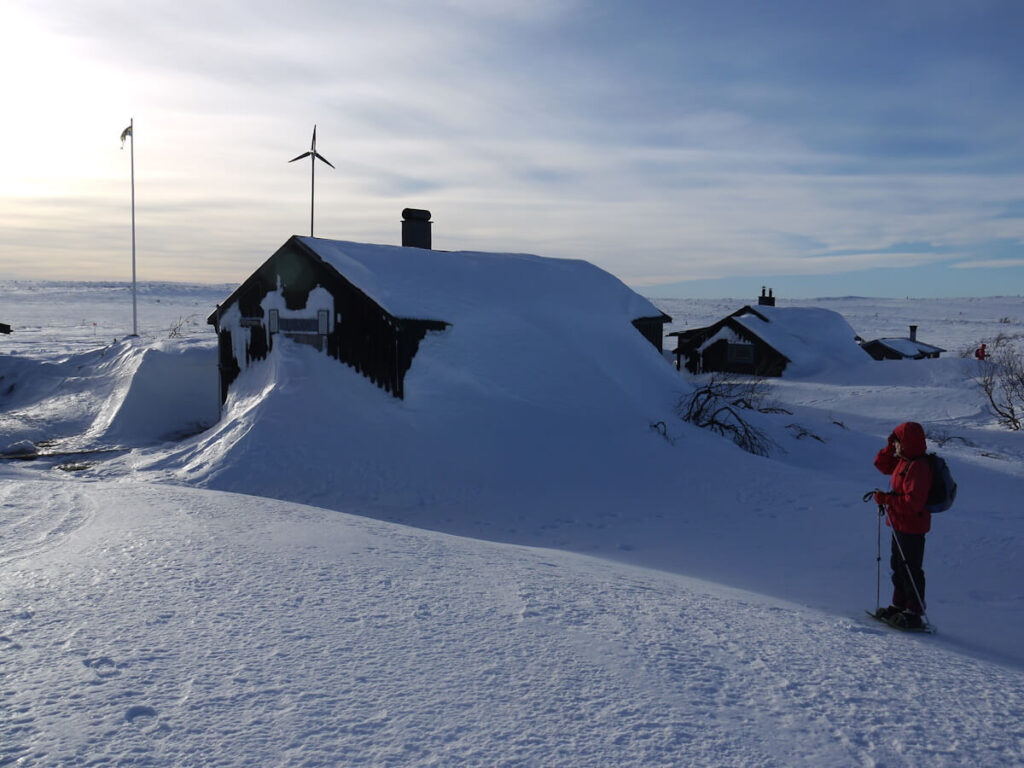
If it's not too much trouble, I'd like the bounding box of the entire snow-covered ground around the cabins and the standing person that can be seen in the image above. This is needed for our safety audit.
[0,283,1024,766]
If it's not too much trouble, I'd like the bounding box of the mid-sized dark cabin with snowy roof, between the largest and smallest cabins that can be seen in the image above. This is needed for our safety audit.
[669,296,869,377]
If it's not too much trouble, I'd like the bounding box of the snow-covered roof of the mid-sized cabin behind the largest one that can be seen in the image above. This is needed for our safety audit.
[733,306,871,376]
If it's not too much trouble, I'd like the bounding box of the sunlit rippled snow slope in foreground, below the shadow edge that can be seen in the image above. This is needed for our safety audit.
[0,480,1024,766]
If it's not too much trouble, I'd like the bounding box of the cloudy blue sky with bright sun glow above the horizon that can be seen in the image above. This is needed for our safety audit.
[0,0,1024,298]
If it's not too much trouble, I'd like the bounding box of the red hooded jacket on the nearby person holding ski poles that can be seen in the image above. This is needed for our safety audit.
[874,421,932,534]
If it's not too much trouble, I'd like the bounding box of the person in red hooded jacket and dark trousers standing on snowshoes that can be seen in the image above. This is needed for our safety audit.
[874,421,932,629]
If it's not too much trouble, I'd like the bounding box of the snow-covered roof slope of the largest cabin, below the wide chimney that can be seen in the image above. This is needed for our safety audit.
[296,238,662,323]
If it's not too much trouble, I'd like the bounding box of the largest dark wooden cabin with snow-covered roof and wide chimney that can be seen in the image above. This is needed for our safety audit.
[208,230,672,402]
